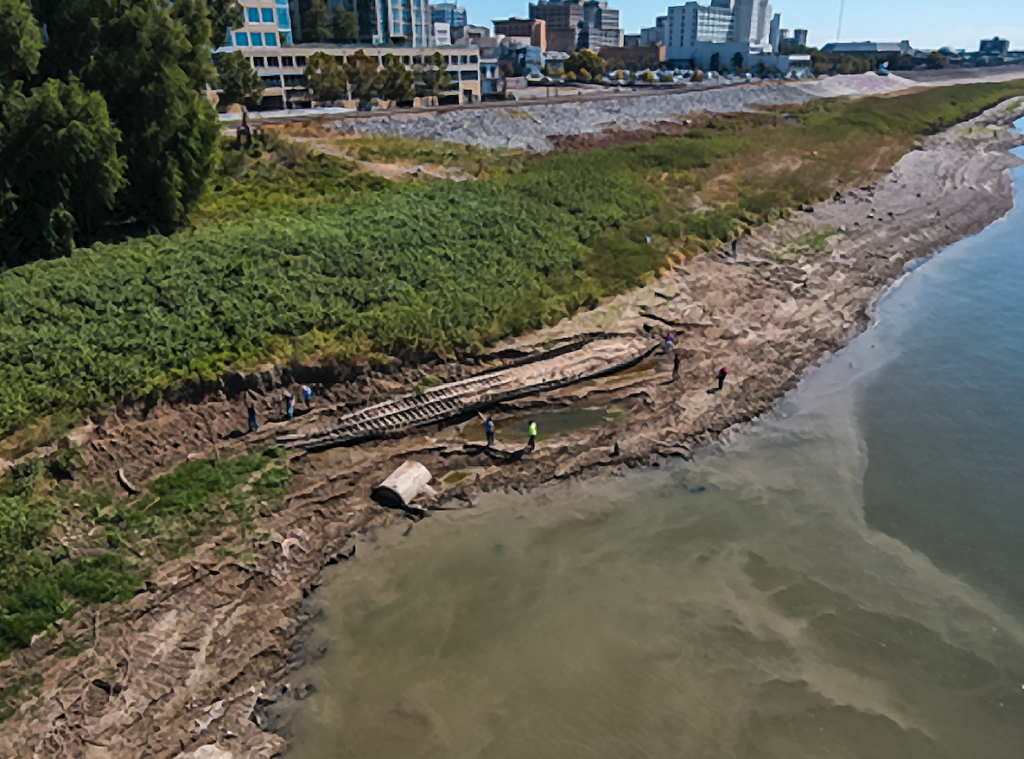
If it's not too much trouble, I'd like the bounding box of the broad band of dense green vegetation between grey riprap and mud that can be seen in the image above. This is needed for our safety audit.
[0,82,1024,435]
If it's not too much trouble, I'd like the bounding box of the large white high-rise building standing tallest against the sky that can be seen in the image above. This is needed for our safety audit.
[667,0,772,67]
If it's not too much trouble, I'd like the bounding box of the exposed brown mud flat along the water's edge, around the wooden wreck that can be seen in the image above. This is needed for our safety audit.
[0,101,1024,759]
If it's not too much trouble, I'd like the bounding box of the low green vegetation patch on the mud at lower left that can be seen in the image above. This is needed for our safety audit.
[0,449,290,655]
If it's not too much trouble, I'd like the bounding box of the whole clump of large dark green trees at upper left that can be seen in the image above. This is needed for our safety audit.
[0,0,234,269]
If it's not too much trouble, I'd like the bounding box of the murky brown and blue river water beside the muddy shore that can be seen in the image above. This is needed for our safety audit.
[280,127,1024,759]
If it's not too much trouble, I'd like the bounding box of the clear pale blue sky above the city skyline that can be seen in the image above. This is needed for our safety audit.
[456,0,1024,50]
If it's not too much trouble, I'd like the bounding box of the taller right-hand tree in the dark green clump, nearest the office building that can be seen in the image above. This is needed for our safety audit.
[37,0,219,226]
